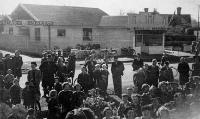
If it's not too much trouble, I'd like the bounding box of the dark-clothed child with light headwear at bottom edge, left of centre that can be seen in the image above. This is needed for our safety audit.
[47,90,59,119]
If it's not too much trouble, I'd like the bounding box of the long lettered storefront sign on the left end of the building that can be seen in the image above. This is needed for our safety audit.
[0,20,53,26]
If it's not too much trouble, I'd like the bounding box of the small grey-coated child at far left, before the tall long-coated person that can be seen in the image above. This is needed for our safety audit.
[4,69,15,89]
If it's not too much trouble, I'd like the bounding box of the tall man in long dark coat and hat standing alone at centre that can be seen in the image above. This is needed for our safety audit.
[111,56,124,97]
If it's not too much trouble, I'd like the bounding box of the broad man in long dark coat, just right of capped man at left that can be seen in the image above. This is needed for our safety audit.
[39,54,58,97]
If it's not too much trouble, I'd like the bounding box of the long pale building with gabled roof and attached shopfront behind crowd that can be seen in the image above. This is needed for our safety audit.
[0,4,195,54]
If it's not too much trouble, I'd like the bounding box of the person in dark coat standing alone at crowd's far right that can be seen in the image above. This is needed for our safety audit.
[178,57,190,85]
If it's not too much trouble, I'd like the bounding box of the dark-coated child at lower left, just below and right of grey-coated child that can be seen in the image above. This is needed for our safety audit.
[10,79,21,105]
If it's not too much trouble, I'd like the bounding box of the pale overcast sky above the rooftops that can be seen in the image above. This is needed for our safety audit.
[0,0,200,19]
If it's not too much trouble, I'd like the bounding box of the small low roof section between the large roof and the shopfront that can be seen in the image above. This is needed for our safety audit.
[99,16,128,28]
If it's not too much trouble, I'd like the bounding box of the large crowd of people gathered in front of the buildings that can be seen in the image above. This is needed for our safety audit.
[0,51,200,119]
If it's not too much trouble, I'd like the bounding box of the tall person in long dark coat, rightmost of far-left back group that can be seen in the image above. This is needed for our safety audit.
[12,50,23,78]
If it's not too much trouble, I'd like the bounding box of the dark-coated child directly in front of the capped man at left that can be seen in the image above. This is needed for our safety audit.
[22,82,35,109]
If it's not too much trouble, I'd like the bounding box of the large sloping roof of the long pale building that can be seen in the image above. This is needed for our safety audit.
[15,4,108,26]
